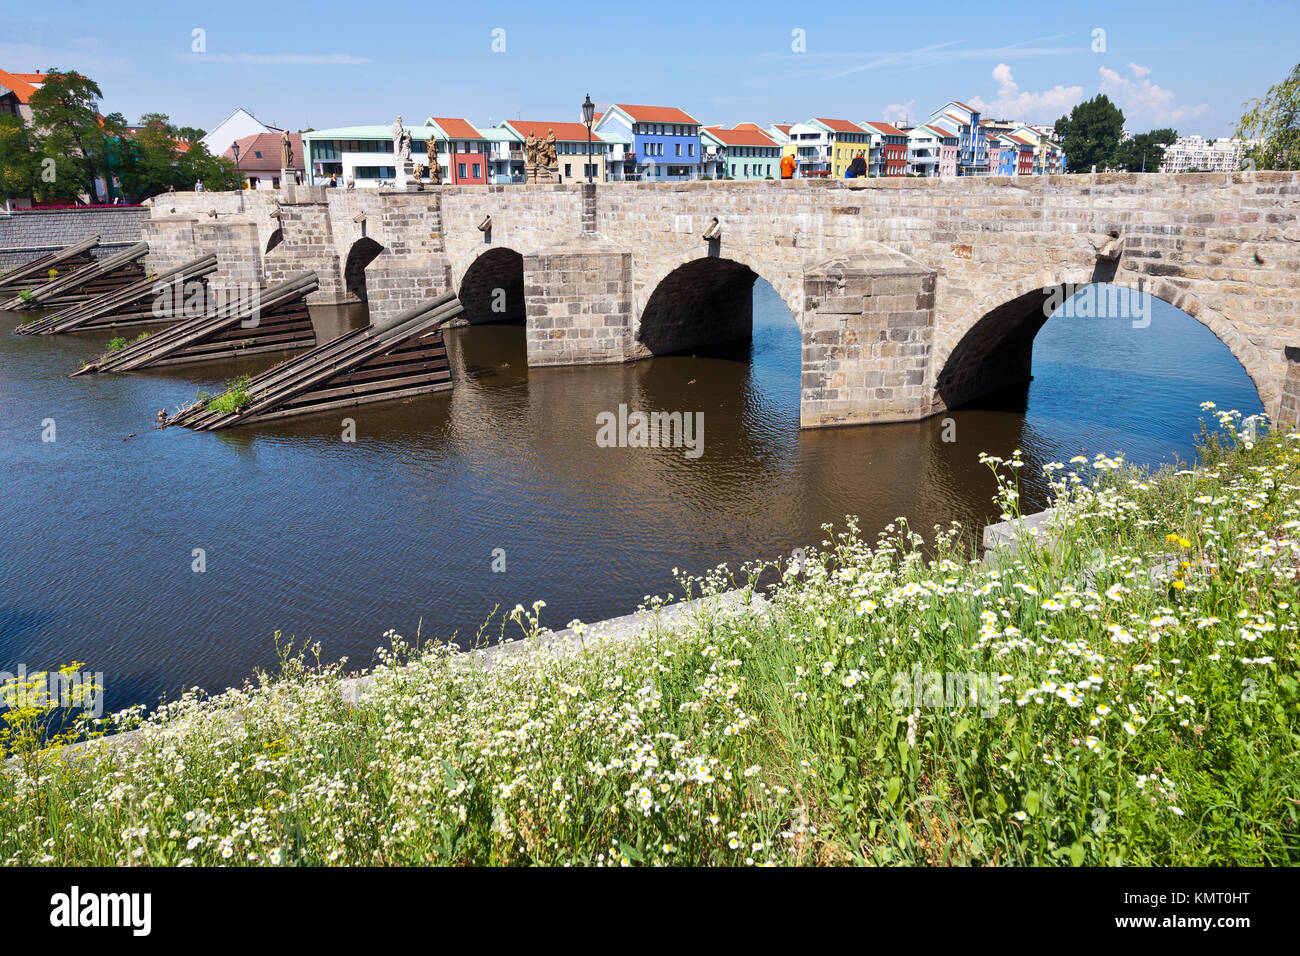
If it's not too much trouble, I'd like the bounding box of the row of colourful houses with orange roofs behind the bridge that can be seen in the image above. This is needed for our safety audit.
[302,100,1065,186]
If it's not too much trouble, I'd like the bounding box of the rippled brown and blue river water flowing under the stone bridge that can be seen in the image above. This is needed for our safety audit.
[0,282,1261,708]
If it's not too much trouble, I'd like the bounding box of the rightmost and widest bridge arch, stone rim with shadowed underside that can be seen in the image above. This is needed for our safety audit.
[932,269,1282,416]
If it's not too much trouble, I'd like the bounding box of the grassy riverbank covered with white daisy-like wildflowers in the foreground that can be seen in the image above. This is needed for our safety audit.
[0,403,1300,865]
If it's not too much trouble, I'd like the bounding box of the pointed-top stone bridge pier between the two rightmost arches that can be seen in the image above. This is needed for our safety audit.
[800,242,936,428]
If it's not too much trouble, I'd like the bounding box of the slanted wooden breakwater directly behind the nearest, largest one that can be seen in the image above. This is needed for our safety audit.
[73,272,317,375]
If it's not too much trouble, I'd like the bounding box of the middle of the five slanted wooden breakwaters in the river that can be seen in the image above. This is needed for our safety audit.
[14,255,217,336]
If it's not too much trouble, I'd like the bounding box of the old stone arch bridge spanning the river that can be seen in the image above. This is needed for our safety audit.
[143,172,1300,427]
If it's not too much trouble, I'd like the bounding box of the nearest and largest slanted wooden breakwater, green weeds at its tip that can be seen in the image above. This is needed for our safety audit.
[168,293,464,431]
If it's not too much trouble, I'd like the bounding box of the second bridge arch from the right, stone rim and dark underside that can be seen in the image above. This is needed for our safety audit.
[634,255,800,355]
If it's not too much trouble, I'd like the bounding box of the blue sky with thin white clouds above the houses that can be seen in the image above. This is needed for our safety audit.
[0,0,1300,135]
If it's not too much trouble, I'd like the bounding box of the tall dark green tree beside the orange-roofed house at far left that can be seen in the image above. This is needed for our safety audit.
[31,69,113,199]
